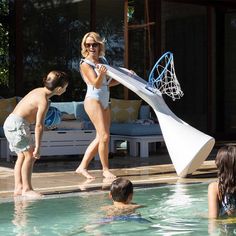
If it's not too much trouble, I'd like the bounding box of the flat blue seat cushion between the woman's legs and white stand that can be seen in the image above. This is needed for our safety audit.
[110,122,162,136]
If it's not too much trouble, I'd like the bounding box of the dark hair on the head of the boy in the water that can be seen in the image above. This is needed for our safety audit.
[110,178,133,202]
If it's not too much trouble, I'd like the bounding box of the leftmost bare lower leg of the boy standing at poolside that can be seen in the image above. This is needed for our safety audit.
[14,152,24,196]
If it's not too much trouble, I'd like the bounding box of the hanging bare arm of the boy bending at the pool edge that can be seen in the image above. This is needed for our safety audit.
[33,101,48,159]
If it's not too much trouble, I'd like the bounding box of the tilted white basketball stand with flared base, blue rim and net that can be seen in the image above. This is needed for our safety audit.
[105,62,215,177]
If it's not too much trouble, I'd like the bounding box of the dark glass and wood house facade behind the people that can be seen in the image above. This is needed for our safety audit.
[0,0,236,140]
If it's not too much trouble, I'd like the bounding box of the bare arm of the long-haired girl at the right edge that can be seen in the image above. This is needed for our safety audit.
[208,182,219,219]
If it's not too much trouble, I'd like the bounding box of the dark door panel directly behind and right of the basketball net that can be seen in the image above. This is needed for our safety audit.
[162,2,210,131]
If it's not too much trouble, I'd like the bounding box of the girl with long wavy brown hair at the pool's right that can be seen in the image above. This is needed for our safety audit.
[208,145,236,218]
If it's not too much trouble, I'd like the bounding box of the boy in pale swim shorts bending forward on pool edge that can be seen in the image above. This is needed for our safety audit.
[3,71,69,198]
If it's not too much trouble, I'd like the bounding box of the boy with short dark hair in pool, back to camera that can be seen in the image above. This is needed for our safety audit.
[102,178,142,216]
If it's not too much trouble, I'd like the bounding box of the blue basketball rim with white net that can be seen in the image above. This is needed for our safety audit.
[146,52,184,101]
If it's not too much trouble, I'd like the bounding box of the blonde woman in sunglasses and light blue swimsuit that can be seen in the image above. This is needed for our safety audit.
[76,32,118,179]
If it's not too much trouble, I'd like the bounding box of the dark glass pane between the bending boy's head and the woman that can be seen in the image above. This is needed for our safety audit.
[22,0,90,100]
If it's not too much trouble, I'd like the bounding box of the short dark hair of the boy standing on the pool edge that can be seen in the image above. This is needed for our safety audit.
[43,70,69,91]
